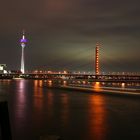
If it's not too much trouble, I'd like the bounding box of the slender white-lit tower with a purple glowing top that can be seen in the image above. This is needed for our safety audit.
[20,31,27,74]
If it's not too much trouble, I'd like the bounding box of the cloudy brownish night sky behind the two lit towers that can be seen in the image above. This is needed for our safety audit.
[0,0,140,72]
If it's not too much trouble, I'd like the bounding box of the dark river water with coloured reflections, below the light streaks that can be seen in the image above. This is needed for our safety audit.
[0,80,140,140]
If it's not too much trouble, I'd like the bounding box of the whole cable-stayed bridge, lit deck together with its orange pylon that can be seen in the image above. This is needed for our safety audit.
[0,43,140,82]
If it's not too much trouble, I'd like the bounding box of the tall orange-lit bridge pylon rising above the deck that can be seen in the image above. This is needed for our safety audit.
[95,43,99,75]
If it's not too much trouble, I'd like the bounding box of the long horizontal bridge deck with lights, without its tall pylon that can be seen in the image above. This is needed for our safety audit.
[0,72,140,82]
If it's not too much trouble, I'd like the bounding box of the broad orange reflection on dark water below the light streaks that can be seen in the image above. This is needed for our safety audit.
[89,95,107,140]
